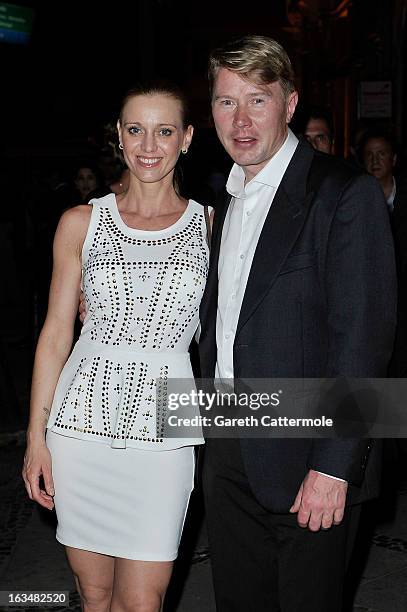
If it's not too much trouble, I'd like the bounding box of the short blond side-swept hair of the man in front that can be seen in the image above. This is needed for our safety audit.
[208,36,295,98]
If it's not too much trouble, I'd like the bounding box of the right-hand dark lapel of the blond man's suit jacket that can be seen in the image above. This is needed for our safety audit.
[236,141,314,336]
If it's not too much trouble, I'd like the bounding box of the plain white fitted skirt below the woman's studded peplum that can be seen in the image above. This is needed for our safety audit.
[47,430,194,561]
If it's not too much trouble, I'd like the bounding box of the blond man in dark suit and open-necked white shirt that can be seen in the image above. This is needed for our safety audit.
[200,36,395,612]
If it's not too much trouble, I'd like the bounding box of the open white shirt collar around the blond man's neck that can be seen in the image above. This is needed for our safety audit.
[226,128,298,198]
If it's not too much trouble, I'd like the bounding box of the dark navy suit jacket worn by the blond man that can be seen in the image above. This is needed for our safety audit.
[200,141,396,512]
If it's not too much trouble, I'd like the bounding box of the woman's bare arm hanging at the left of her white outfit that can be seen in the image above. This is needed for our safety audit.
[23,206,92,509]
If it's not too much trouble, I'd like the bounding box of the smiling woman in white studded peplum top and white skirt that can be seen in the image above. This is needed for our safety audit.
[23,82,208,612]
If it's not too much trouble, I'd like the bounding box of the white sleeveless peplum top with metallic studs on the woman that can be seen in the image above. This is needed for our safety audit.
[48,194,208,450]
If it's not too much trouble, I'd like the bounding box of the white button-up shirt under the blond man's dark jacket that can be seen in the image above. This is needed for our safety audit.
[216,130,298,379]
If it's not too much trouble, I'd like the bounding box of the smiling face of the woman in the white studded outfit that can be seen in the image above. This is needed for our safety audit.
[117,94,193,183]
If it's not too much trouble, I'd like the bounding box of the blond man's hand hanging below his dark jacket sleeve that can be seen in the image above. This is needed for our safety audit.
[290,470,348,531]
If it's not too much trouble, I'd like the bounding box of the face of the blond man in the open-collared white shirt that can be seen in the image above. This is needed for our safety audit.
[212,68,298,181]
